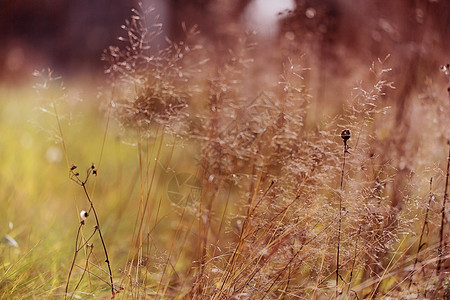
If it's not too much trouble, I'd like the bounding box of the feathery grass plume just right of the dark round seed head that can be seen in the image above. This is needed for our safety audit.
[326,59,400,297]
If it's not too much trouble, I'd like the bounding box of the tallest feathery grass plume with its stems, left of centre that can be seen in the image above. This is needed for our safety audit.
[103,4,204,294]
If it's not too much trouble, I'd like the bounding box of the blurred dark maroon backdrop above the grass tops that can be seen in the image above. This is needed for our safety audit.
[0,0,450,83]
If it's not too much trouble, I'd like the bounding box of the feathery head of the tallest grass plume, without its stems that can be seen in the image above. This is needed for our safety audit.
[103,4,199,135]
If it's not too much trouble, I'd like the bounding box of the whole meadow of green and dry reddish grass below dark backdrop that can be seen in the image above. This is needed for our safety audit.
[0,2,450,299]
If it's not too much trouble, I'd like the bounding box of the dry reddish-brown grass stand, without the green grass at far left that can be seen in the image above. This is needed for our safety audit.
[0,2,450,299]
